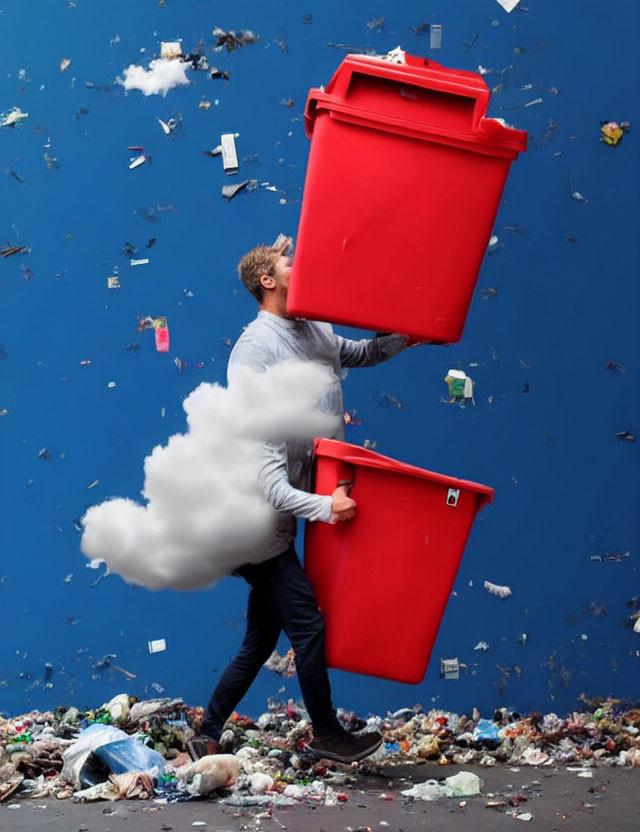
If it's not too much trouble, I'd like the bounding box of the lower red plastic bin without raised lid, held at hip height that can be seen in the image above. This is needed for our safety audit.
[304,439,493,684]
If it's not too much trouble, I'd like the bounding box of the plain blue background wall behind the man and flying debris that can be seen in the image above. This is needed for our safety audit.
[0,0,640,714]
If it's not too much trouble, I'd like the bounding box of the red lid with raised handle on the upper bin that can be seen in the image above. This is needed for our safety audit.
[305,53,527,155]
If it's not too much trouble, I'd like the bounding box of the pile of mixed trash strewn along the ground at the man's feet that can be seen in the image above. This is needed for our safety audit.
[0,694,640,806]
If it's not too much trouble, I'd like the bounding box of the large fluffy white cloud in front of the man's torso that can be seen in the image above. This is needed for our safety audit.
[80,362,336,590]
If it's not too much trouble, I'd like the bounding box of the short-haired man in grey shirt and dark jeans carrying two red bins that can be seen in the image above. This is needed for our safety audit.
[189,238,407,763]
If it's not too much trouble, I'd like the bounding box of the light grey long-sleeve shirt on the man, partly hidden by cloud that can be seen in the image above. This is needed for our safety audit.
[227,310,407,561]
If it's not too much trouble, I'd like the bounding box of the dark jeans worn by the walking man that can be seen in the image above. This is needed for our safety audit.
[201,546,338,740]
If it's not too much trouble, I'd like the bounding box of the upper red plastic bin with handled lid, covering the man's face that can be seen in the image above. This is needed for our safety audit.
[287,55,527,343]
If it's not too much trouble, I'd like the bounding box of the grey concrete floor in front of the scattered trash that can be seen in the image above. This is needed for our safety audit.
[0,765,640,832]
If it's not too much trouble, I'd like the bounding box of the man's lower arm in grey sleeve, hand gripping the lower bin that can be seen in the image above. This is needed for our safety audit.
[258,442,356,523]
